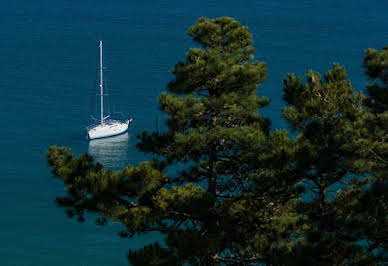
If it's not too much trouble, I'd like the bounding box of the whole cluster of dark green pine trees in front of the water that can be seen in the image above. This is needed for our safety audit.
[47,17,388,265]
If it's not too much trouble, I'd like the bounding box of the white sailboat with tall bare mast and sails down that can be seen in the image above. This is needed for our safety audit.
[87,41,133,140]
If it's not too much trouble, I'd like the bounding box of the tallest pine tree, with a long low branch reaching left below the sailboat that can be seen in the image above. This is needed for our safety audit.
[47,17,298,265]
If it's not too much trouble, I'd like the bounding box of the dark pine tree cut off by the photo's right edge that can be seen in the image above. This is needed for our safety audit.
[354,46,388,263]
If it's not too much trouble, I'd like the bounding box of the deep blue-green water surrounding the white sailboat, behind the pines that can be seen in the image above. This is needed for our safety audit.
[0,0,388,265]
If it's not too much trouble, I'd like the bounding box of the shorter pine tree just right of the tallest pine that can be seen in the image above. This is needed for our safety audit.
[284,64,388,265]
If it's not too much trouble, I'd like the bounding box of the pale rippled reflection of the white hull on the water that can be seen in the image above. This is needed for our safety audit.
[88,133,130,169]
